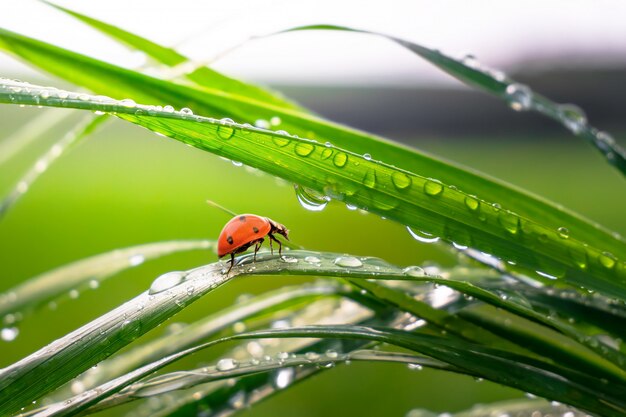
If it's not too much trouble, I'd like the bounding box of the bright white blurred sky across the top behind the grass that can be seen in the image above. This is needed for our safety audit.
[0,0,626,85]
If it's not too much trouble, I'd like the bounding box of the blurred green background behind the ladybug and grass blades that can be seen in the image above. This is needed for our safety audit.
[0,79,626,416]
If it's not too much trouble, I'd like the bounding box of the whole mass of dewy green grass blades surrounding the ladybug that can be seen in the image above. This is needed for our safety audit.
[0,5,626,416]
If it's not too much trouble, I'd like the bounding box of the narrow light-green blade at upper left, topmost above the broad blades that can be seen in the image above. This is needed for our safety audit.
[42,0,302,110]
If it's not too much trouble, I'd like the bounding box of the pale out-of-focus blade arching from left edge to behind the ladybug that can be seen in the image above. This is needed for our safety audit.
[0,240,216,324]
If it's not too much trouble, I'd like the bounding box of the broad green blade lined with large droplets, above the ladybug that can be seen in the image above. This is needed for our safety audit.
[0,81,626,300]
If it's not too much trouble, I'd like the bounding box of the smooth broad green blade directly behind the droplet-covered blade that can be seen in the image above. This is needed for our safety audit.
[0,29,626,266]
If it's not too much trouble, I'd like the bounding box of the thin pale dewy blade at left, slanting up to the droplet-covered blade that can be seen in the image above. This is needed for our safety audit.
[0,112,107,219]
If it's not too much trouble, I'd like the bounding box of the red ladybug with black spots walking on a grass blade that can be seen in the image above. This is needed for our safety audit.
[217,214,289,274]
